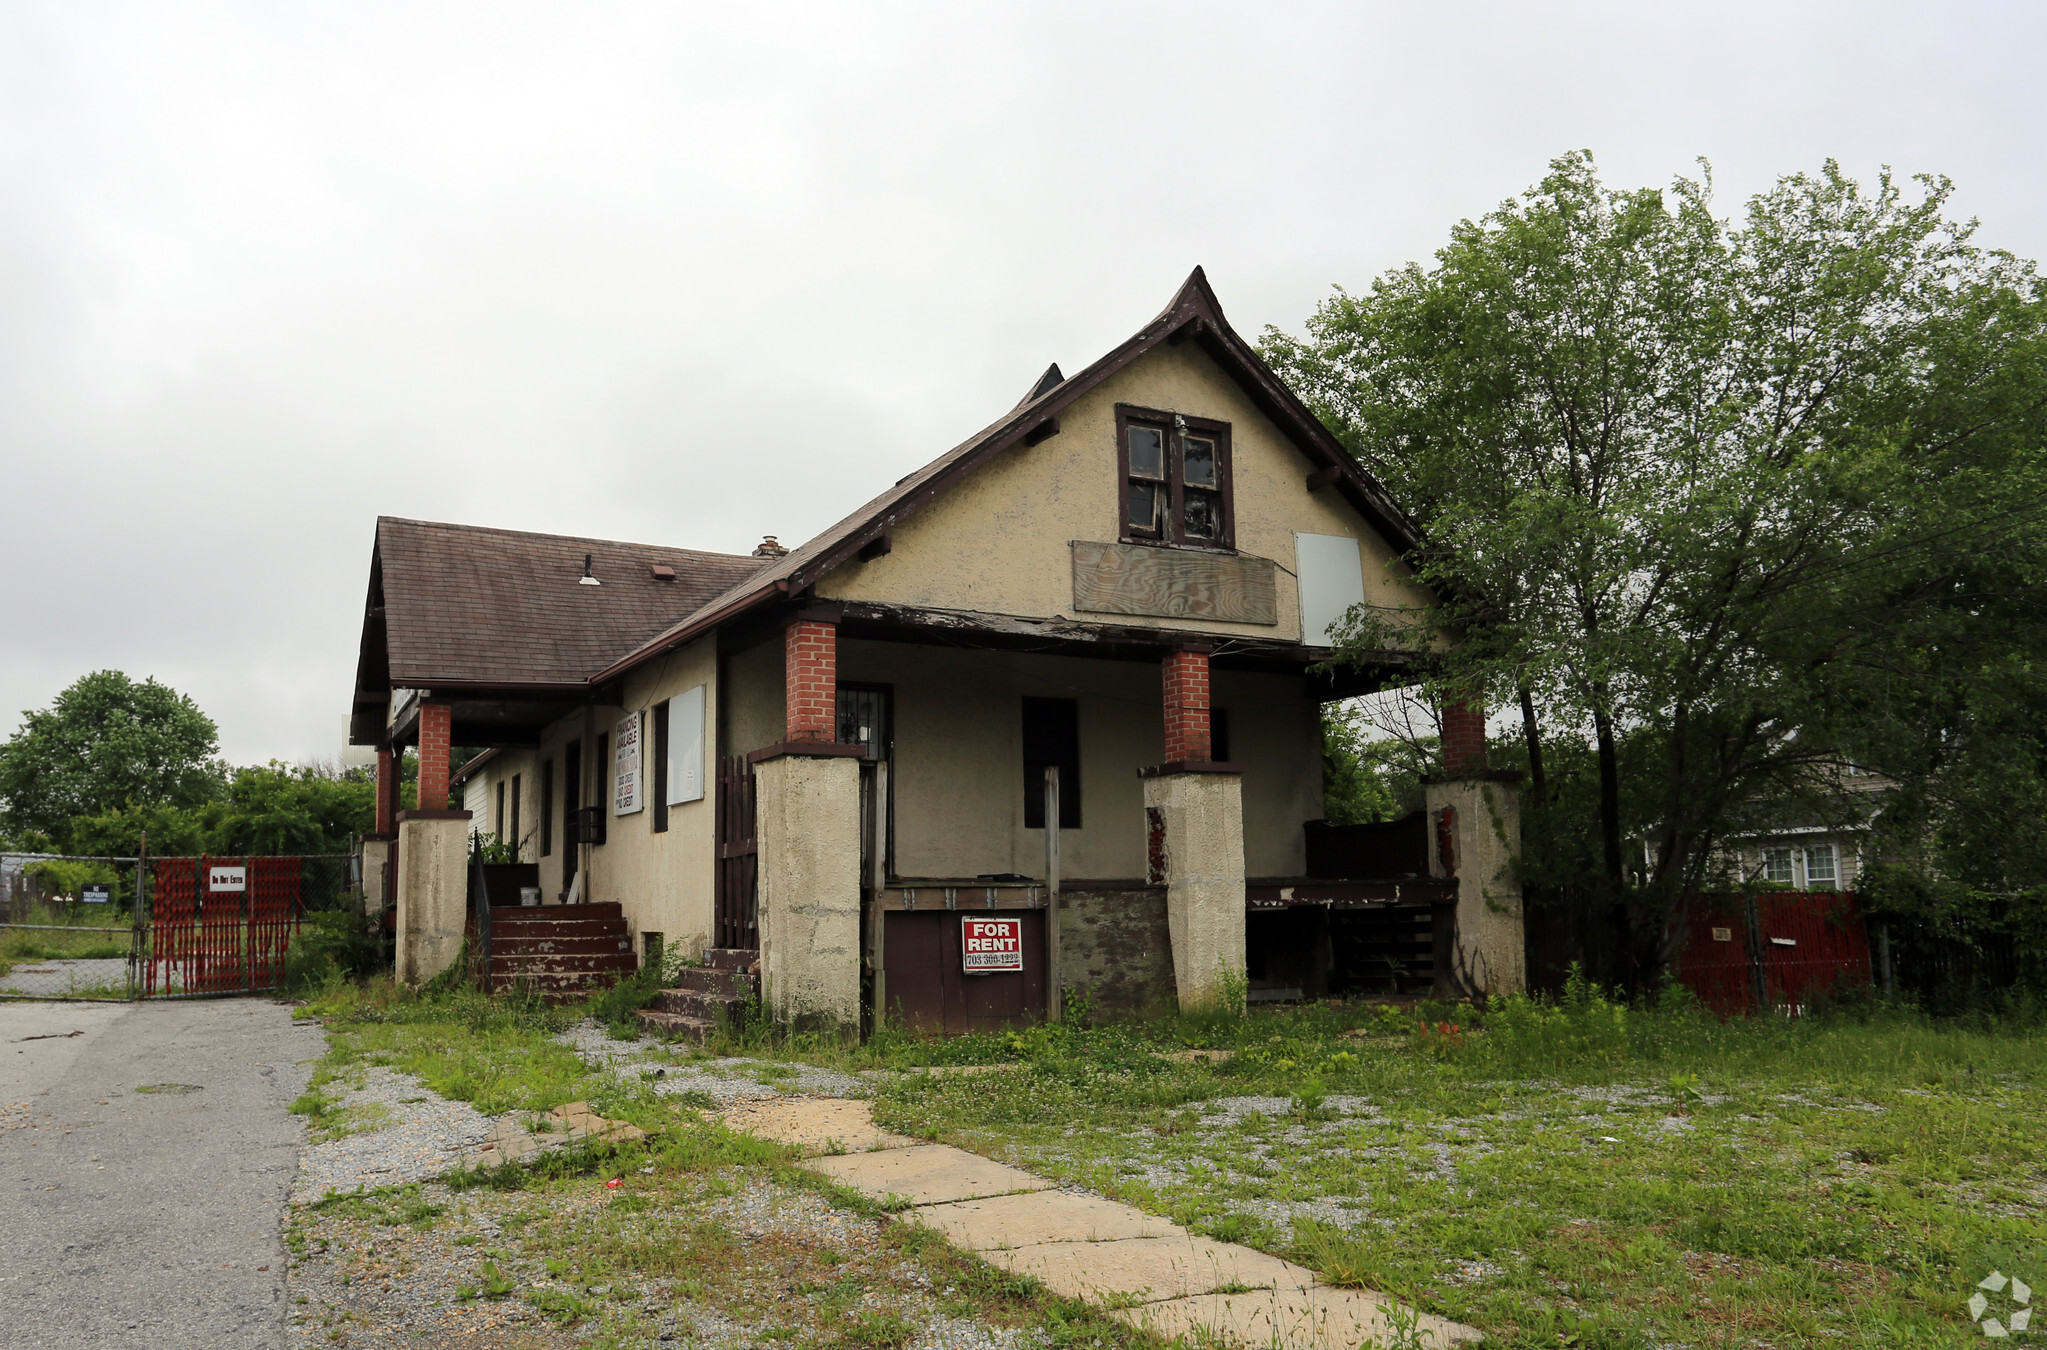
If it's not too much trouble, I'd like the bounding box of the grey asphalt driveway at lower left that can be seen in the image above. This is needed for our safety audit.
[0,998,321,1350]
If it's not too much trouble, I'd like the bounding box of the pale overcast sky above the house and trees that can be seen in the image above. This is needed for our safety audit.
[0,0,2047,761]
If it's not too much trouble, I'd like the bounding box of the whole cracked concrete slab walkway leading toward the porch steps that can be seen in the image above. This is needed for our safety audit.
[725,1098,1480,1350]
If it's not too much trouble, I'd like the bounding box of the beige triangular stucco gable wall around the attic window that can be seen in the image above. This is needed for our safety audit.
[817,344,1427,640]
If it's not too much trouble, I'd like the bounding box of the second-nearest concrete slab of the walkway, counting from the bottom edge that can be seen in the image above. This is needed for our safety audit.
[983,1238,1314,1301]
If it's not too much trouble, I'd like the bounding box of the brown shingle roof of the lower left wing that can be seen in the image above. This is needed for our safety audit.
[377,515,761,687]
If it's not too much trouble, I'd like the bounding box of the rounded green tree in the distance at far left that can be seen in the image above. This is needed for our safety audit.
[0,671,225,843]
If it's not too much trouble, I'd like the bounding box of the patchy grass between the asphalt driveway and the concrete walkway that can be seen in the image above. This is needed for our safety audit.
[287,1113,1161,1350]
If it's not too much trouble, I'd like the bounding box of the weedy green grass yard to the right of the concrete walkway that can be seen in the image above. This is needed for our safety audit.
[835,990,2047,1348]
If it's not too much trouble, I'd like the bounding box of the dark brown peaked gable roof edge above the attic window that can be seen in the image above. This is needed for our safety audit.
[592,268,1421,683]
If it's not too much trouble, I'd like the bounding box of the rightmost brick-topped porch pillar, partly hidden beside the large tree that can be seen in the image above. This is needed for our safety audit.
[1423,704,1527,994]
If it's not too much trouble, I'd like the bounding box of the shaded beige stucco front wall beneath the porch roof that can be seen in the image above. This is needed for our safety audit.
[839,640,1322,878]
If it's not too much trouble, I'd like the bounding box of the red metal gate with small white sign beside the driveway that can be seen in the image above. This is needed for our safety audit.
[141,857,305,998]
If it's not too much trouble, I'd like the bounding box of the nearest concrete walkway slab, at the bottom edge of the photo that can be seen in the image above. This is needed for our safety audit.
[1109,1287,1478,1350]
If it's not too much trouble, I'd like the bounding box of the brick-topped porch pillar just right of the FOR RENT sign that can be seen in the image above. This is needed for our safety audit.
[1144,646,1245,1013]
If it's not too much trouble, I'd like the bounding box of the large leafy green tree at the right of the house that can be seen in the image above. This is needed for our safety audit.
[1263,153,2047,980]
